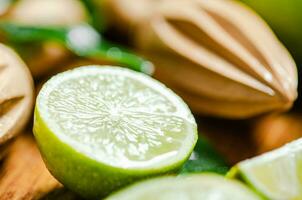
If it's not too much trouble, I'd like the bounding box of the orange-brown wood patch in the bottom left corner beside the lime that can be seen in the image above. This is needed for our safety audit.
[0,134,62,200]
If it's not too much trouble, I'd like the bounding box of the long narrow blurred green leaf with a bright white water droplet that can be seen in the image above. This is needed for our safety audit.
[0,22,153,74]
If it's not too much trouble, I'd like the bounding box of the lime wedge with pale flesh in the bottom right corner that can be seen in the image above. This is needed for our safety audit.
[228,139,302,200]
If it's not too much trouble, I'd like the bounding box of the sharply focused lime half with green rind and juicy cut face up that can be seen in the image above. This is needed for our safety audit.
[34,66,197,198]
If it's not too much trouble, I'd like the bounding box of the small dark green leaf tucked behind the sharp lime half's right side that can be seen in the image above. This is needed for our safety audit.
[180,137,230,174]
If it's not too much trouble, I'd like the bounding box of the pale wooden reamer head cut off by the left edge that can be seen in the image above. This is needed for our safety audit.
[0,44,34,144]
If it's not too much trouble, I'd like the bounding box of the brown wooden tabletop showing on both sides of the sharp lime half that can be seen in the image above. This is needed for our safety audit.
[0,60,302,200]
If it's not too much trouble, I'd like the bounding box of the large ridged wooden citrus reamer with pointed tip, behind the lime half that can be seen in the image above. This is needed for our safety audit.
[104,0,297,118]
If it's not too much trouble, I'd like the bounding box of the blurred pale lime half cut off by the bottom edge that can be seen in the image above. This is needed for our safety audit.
[106,174,260,200]
